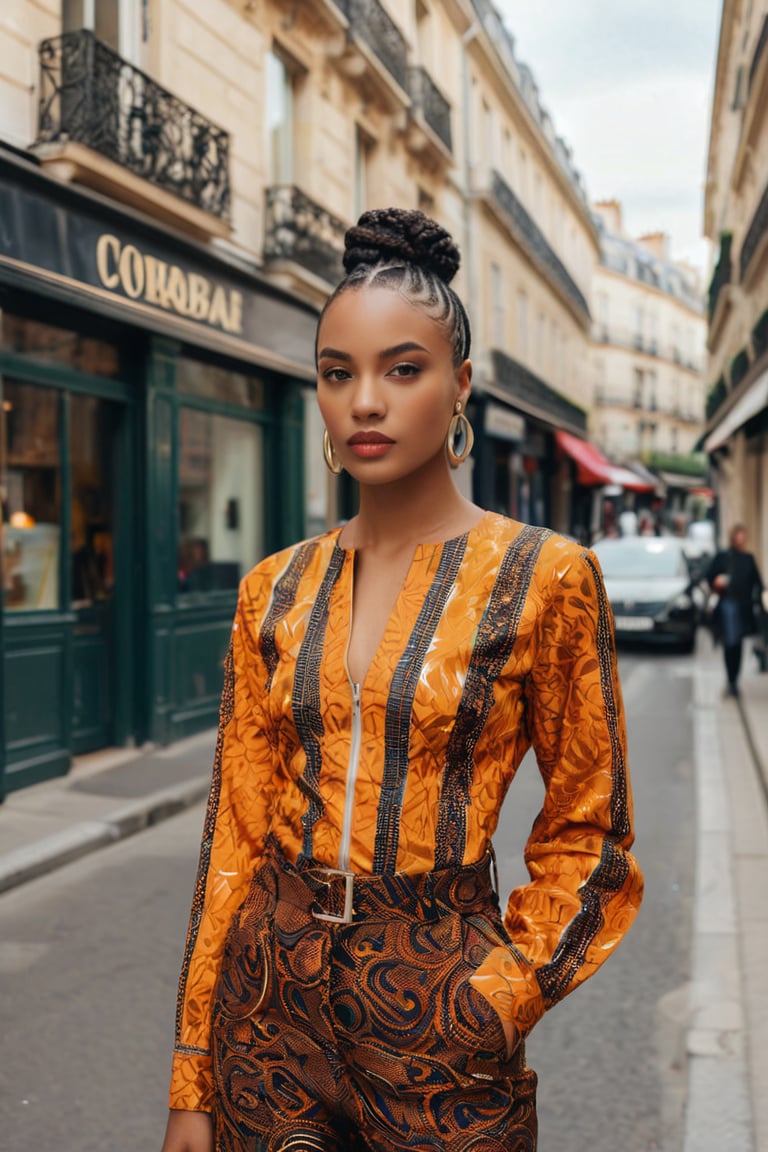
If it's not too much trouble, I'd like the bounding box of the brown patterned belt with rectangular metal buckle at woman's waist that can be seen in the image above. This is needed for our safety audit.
[272,844,499,924]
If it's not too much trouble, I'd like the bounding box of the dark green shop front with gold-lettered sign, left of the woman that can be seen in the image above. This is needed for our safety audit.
[0,150,315,797]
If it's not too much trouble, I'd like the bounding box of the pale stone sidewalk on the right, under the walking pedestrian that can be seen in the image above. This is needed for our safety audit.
[684,652,768,1152]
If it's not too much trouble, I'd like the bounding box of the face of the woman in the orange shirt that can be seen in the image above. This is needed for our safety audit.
[318,288,472,484]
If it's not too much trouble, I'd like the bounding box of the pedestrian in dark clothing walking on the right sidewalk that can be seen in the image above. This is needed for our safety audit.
[707,524,762,696]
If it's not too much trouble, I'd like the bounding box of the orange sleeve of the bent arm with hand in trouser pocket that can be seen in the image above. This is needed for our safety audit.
[471,552,642,1038]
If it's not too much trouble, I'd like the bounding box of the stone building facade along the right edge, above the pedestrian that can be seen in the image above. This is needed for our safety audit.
[704,0,768,573]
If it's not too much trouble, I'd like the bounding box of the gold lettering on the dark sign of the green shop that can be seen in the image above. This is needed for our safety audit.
[96,233,243,335]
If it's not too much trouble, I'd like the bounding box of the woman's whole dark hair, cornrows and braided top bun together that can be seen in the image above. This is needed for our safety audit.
[318,209,472,367]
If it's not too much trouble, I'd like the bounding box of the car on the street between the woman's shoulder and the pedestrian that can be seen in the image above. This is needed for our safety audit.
[594,536,705,652]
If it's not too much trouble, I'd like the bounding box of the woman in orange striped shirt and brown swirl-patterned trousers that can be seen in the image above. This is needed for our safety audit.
[164,209,641,1152]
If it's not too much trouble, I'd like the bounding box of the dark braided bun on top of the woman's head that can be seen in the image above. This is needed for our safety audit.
[344,209,461,285]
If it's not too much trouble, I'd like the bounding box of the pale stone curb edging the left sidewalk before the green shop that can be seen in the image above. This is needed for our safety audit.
[0,772,211,893]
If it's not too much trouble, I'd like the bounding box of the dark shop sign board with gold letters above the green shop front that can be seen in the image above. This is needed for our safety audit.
[0,169,317,379]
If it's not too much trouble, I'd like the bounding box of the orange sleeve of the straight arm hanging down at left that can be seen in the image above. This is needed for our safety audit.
[169,584,274,1112]
